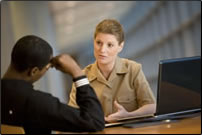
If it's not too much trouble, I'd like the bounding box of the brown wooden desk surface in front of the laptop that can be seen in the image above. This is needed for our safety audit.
[96,115,201,134]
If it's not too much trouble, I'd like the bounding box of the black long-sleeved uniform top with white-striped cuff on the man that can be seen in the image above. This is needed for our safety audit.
[1,76,105,134]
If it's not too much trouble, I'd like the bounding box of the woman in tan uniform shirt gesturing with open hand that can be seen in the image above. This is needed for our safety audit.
[69,19,156,122]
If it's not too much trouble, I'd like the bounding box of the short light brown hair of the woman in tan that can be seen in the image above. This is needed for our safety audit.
[94,19,124,44]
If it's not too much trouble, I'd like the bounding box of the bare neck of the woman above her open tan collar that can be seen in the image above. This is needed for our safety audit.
[98,61,115,80]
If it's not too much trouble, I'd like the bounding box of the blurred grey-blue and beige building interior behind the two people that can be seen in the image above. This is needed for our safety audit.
[1,1,201,102]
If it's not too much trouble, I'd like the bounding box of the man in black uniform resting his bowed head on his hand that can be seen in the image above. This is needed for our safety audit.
[1,35,105,133]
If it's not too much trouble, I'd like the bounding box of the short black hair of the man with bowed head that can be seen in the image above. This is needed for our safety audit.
[11,35,53,72]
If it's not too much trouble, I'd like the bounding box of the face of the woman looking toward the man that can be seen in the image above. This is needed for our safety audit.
[94,33,124,65]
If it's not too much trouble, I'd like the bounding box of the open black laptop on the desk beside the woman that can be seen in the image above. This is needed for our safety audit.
[105,56,201,127]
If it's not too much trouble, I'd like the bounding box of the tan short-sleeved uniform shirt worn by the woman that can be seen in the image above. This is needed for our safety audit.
[69,57,155,116]
